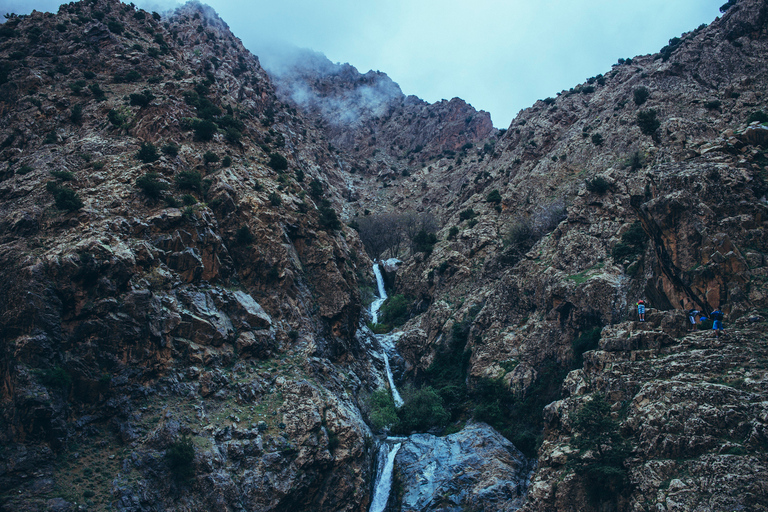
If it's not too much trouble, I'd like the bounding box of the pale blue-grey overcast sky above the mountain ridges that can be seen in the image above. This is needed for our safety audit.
[0,0,725,128]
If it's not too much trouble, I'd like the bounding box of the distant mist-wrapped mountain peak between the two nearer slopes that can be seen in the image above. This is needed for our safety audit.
[266,49,497,213]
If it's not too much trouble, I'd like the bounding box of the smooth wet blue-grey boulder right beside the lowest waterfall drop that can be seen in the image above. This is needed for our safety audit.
[394,423,534,512]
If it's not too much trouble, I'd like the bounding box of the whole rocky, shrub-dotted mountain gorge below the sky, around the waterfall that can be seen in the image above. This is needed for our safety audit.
[0,0,768,511]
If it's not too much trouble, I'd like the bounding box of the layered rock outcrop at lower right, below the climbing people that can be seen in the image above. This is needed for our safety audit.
[523,317,768,511]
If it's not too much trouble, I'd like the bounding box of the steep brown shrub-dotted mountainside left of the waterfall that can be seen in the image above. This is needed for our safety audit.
[0,0,384,511]
